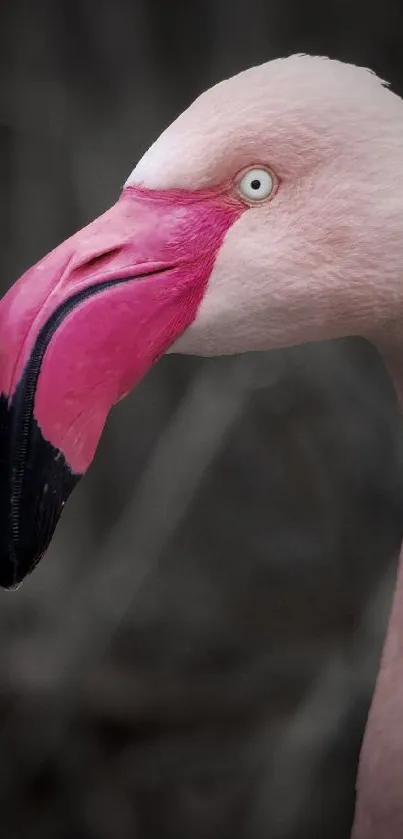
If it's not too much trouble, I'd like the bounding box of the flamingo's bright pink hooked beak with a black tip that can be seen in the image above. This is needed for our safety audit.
[0,187,241,587]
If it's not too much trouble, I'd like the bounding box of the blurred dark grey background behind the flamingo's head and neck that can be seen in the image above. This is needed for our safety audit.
[0,0,403,839]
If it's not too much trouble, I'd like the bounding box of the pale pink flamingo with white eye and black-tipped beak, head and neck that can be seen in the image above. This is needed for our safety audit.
[0,55,403,839]
